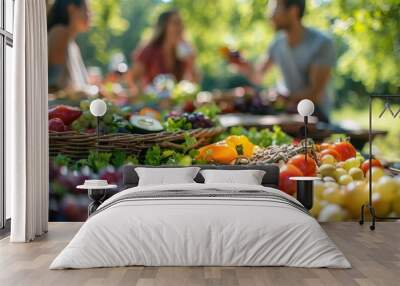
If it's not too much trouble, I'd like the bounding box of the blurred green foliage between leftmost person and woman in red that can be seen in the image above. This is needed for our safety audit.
[78,0,160,69]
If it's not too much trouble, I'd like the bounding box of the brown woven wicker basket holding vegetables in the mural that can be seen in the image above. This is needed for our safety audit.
[49,127,225,159]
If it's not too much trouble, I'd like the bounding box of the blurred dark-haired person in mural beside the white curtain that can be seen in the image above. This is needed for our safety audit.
[47,0,90,91]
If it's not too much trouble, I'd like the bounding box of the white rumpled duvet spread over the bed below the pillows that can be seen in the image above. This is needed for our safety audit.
[50,184,351,269]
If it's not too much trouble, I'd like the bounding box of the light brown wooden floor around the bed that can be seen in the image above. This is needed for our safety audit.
[0,222,400,286]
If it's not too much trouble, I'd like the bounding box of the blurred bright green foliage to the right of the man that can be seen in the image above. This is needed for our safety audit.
[308,0,400,93]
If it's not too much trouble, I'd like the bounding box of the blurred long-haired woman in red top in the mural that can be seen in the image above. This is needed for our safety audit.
[128,10,199,95]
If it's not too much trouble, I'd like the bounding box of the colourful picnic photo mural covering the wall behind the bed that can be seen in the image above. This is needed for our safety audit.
[47,0,400,221]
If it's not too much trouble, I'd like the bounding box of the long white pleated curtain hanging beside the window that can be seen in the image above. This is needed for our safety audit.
[6,0,49,242]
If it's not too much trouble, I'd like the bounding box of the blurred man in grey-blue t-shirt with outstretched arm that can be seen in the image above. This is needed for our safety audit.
[236,0,336,122]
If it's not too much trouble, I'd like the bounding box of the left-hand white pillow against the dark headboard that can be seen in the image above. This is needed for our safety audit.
[135,167,200,186]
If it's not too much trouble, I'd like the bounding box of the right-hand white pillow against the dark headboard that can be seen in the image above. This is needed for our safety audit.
[200,170,265,185]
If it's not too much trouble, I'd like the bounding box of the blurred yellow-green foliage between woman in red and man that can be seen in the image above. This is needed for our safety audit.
[170,0,273,74]
